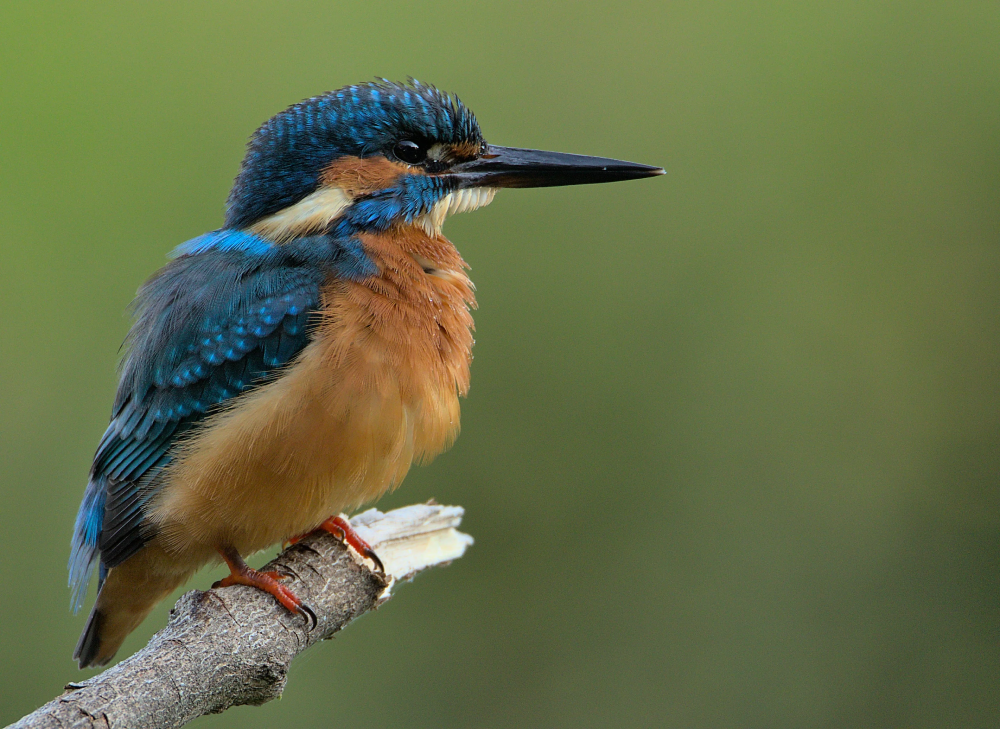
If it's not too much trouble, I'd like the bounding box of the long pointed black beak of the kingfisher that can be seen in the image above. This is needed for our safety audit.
[450,145,663,187]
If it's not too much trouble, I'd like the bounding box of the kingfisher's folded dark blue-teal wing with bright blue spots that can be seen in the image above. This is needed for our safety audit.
[70,240,322,604]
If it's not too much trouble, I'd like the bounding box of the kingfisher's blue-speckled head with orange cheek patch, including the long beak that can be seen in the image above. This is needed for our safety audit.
[225,80,663,242]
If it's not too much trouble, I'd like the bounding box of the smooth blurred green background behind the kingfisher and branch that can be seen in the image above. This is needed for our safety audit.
[0,1,1000,729]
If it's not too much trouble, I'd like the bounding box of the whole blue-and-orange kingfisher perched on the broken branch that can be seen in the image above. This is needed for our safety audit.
[69,79,663,668]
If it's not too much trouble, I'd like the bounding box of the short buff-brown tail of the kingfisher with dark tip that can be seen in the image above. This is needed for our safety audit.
[73,544,193,668]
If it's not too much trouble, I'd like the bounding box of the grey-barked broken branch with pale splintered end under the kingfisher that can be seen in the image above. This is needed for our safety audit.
[11,503,472,729]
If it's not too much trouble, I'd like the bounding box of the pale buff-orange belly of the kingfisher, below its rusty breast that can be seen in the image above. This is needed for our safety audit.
[151,270,471,559]
